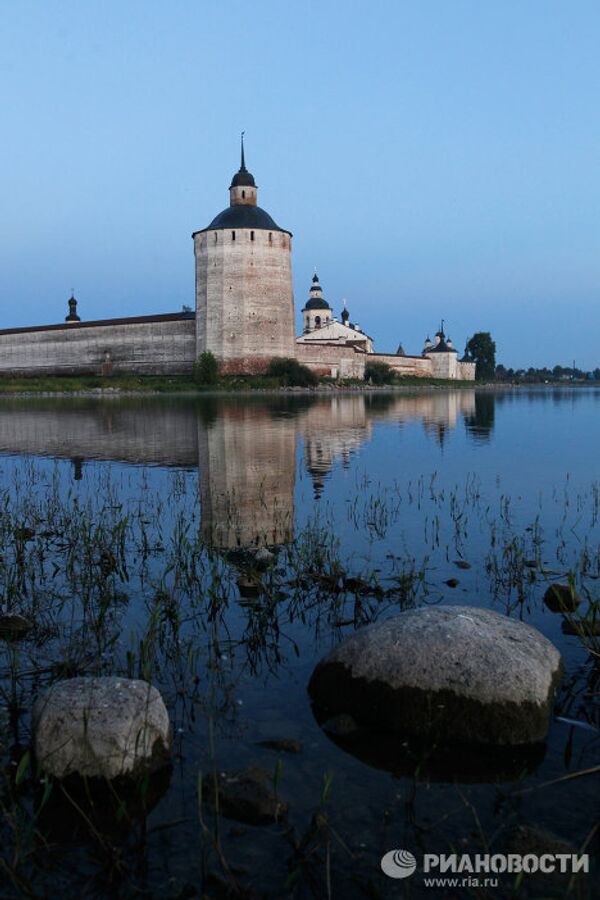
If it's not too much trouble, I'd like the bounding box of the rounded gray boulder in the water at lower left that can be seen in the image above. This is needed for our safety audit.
[33,677,171,779]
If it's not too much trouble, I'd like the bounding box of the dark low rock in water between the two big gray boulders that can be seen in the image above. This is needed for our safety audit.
[203,766,288,825]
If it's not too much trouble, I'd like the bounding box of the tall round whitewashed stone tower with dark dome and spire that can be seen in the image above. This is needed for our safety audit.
[192,135,295,373]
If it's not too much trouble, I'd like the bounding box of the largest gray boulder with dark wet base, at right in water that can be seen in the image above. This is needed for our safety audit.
[309,606,562,744]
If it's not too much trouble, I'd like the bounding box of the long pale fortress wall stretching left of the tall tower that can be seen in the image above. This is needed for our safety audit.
[0,314,196,375]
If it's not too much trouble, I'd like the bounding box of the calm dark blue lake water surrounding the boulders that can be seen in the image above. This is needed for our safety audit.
[0,388,600,898]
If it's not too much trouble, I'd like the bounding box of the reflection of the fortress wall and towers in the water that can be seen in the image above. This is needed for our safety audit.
[0,390,496,549]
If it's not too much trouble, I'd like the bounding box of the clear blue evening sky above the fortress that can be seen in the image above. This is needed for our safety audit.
[0,0,600,369]
